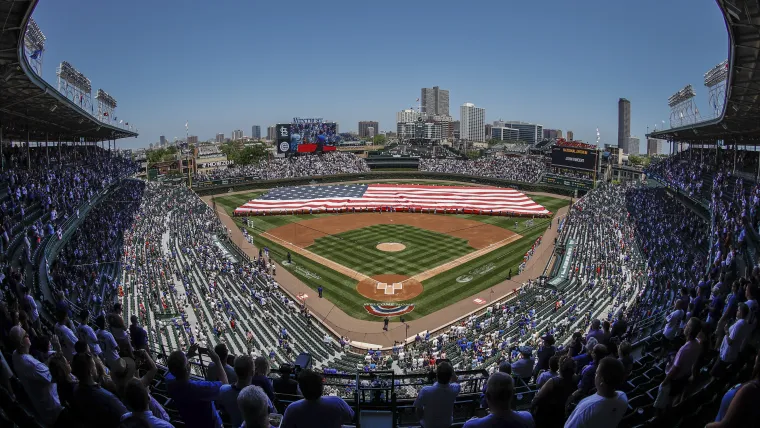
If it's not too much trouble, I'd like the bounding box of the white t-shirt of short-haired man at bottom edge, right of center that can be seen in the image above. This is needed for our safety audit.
[565,391,628,428]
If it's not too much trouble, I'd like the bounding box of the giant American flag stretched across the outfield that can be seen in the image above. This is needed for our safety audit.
[235,184,550,216]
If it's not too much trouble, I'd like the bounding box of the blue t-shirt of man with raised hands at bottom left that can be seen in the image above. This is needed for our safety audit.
[166,373,222,428]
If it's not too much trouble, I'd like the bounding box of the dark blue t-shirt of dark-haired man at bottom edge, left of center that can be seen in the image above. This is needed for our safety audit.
[280,397,354,428]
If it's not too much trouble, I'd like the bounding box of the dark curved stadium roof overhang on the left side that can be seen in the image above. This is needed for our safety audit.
[0,0,137,142]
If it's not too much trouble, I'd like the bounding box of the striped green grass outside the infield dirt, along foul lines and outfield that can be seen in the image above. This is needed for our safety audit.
[211,187,568,321]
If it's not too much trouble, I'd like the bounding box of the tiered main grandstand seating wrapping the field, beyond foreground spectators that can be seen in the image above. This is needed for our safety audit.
[0,144,760,427]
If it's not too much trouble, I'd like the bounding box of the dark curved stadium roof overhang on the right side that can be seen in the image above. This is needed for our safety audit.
[648,0,760,145]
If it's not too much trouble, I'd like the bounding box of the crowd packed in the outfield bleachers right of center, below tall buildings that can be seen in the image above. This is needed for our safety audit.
[419,156,546,183]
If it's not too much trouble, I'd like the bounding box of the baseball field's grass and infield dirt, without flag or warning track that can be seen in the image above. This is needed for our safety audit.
[214,184,568,320]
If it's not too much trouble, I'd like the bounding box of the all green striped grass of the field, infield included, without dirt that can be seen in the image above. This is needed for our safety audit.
[211,183,568,320]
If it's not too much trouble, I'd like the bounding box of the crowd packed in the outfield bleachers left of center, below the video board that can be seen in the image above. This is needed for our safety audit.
[195,152,369,181]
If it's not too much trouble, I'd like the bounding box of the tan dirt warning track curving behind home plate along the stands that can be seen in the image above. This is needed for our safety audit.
[202,190,570,347]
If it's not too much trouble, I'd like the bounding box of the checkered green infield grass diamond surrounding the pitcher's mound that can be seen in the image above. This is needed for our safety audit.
[307,224,475,276]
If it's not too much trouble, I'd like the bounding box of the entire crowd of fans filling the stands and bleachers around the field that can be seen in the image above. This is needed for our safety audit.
[0,145,760,428]
